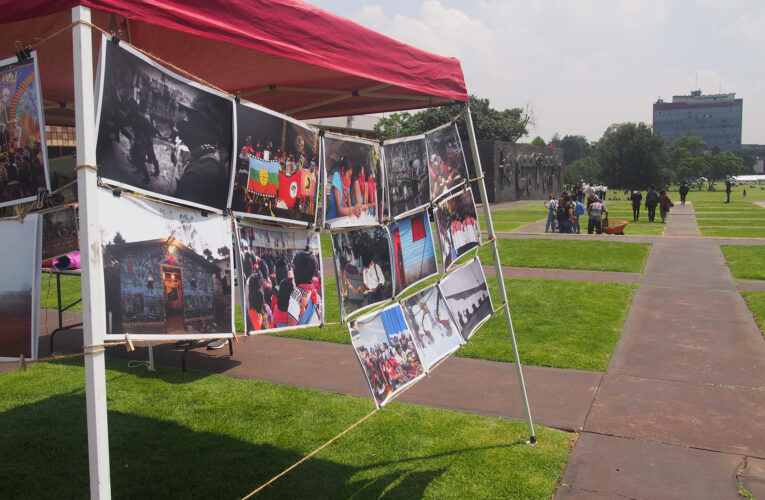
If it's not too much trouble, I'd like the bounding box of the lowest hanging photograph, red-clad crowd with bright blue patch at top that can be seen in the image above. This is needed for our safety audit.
[348,304,425,408]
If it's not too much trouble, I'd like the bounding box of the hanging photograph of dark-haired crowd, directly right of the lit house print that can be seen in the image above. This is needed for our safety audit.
[237,222,324,334]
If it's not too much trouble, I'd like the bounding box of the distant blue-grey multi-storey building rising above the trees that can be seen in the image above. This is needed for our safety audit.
[653,90,744,151]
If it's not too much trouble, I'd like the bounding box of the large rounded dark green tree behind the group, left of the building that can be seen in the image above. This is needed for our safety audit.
[597,123,670,189]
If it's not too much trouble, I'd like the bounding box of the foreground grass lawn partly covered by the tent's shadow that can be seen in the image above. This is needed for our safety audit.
[0,359,573,498]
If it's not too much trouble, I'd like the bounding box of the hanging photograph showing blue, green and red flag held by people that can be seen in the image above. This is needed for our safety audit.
[229,103,319,225]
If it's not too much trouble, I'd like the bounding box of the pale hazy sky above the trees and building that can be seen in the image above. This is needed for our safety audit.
[308,0,765,144]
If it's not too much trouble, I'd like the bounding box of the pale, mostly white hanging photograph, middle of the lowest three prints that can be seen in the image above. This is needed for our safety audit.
[401,285,463,370]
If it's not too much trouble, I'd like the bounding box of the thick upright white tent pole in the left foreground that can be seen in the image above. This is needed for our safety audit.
[72,6,111,499]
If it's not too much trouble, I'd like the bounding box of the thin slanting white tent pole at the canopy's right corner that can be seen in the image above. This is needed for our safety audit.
[465,103,537,444]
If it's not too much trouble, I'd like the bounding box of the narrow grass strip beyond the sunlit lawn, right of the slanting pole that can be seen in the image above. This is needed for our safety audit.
[478,238,648,273]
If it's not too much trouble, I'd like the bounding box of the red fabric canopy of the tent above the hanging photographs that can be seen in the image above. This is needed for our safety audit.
[0,0,468,123]
